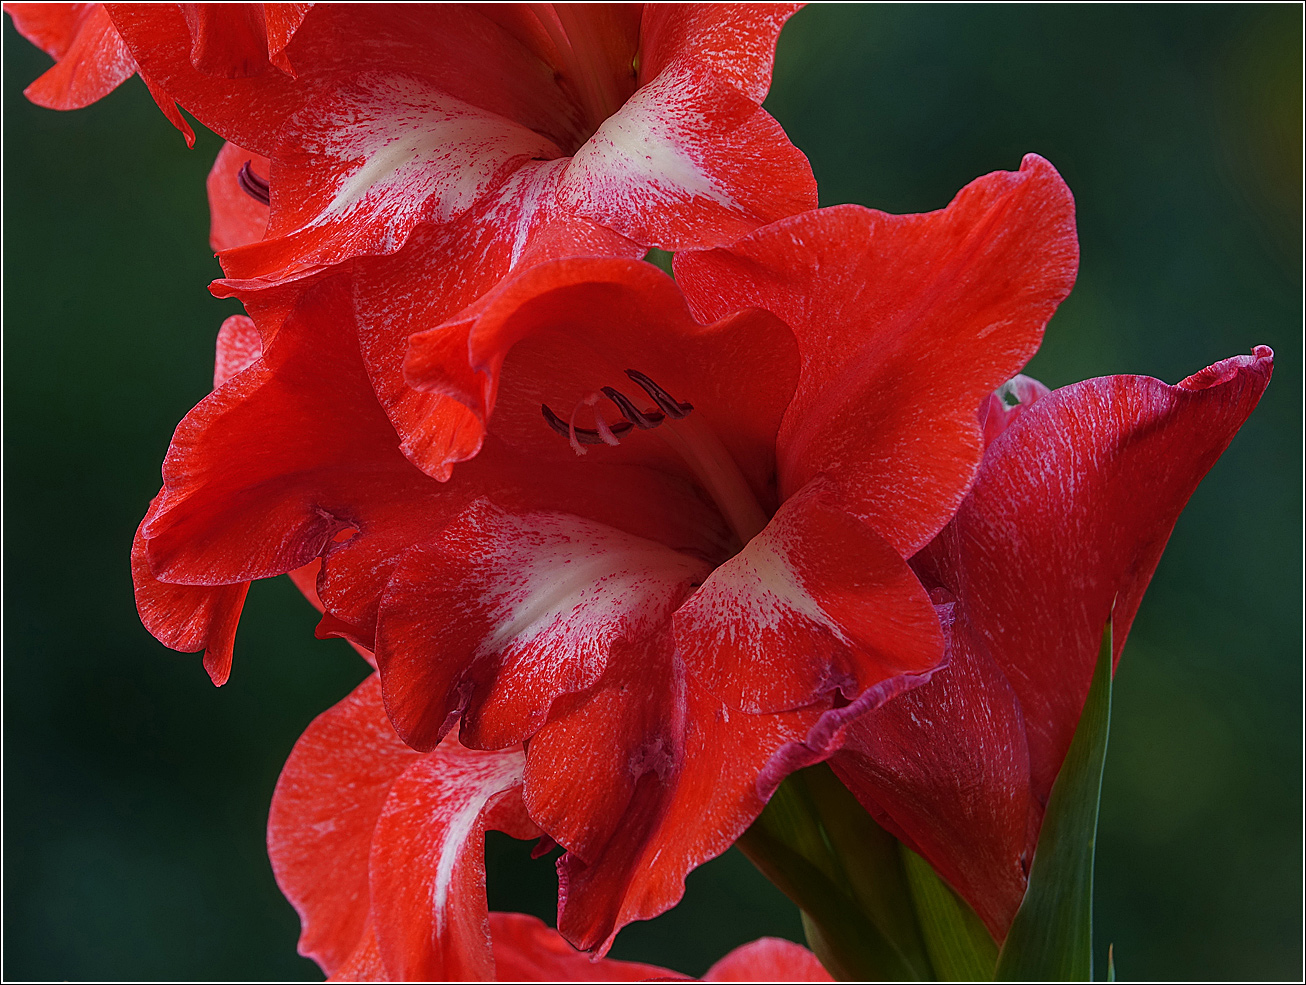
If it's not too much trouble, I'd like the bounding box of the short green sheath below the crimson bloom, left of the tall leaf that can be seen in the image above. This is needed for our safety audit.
[899,844,998,981]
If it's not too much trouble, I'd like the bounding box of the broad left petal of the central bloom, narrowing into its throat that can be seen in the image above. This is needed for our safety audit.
[137,269,721,668]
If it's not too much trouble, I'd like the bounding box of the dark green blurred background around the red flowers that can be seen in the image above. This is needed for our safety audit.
[4,5,1302,980]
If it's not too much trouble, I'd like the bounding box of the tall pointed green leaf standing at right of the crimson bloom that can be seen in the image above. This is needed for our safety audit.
[996,613,1111,981]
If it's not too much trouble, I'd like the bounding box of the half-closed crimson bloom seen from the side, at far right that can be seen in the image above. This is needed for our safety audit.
[831,346,1273,941]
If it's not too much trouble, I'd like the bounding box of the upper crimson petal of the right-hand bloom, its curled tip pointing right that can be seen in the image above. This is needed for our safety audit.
[922,346,1273,801]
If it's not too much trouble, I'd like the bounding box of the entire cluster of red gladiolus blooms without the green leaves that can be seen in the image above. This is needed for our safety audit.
[9,4,1271,980]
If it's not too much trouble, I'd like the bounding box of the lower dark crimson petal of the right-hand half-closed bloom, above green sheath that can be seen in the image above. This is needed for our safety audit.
[831,606,1034,941]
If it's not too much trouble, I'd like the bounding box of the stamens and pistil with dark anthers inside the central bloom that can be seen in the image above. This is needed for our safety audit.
[539,370,769,546]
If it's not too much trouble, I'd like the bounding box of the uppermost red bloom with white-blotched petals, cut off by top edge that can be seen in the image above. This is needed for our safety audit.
[94,4,816,478]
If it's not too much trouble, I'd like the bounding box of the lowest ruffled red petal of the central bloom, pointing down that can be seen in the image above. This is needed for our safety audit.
[535,661,831,954]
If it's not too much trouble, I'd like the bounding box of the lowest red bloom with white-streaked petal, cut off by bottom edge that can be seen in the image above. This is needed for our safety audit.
[268,674,831,981]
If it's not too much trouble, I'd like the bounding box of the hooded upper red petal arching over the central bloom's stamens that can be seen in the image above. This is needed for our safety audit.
[405,260,798,480]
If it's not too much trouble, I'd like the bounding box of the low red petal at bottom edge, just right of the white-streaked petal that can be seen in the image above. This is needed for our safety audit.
[490,913,686,981]
